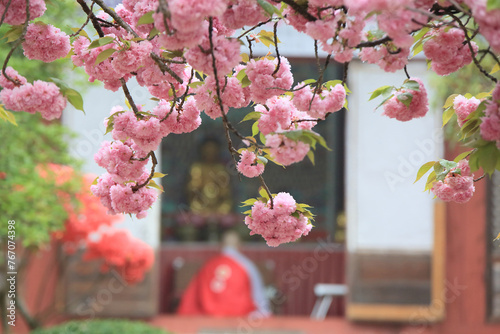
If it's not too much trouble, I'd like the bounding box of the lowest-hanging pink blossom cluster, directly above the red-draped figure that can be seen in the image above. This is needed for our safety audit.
[245,192,312,247]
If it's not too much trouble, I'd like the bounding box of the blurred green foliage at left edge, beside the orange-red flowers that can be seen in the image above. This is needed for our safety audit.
[0,113,81,247]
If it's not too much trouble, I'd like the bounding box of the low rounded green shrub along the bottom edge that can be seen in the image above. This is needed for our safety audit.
[31,319,171,334]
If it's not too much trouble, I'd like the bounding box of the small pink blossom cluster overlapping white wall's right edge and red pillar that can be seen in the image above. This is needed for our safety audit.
[432,159,475,203]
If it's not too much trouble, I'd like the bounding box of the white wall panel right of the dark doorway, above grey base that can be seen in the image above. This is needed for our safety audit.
[346,61,443,251]
